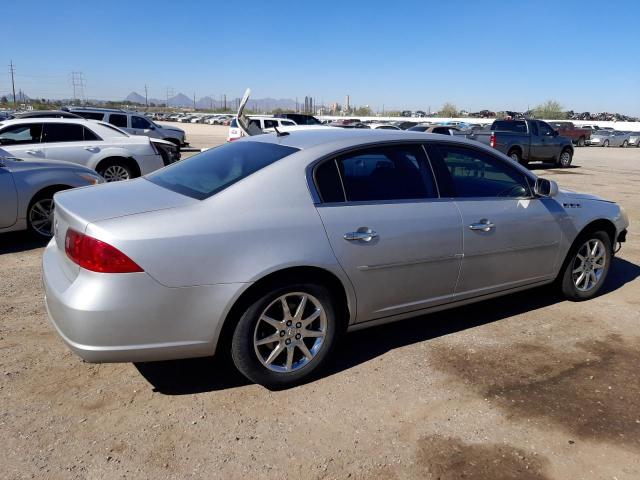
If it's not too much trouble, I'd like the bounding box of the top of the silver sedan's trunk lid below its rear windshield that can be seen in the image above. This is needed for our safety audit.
[55,178,198,228]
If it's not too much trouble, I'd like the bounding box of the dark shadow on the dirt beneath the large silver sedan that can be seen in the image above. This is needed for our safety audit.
[135,257,640,395]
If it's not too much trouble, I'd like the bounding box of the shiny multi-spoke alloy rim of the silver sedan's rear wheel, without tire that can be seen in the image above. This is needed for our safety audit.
[253,292,327,373]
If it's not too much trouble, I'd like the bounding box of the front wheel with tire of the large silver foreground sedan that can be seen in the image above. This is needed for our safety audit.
[561,231,612,302]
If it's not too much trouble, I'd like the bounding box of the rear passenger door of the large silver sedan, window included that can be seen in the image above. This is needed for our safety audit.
[314,144,462,321]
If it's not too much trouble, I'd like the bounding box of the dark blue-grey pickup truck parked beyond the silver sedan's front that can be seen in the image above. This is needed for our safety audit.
[466,120,573,167]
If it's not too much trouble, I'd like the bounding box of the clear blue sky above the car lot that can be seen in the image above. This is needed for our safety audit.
[5,0,640,115]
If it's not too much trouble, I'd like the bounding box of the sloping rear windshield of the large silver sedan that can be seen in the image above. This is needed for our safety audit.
[145,142,298,200]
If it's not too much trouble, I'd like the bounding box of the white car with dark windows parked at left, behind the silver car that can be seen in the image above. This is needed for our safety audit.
[0,118,171,182]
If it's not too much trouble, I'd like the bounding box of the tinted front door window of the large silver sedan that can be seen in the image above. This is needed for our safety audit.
[429,144,530,198]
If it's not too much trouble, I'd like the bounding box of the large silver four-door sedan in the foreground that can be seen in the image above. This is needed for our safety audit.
[43,128,628,387]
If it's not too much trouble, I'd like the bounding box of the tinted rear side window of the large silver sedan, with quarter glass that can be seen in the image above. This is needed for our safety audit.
[316,145,437,202]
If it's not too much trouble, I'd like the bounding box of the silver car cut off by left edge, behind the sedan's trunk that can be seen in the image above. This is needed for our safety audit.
[0,157,104,237]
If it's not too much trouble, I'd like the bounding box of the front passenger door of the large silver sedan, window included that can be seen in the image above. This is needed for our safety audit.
[429,144,562,299]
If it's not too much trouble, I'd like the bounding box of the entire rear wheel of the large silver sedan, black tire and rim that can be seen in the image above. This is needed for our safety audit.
[231,283,338,389]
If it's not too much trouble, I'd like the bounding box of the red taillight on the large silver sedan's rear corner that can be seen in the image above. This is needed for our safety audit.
[64,228,144,273]
